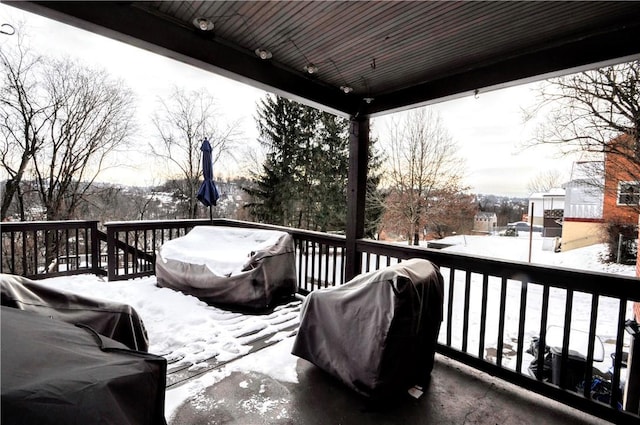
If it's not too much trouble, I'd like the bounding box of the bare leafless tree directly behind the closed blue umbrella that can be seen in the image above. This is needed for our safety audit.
[151,87,239,218]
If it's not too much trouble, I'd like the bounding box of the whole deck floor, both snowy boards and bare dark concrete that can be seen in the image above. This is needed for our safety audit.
[30,275,608,425]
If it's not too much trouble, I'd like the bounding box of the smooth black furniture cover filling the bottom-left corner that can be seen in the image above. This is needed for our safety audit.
[0,306,167,425]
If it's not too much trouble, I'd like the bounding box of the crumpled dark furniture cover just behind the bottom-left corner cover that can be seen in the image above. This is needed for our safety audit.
[0,274,149,351]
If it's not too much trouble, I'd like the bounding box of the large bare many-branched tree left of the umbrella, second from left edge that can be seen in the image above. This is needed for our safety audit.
[34,59,134,220]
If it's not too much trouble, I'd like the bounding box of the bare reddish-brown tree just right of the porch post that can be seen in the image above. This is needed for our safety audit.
[385,108,464,245]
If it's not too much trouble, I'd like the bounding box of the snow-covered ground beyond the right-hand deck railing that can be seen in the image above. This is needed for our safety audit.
[439,232,635,372]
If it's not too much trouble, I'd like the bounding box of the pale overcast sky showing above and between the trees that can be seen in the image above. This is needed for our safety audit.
[0,4,571,196]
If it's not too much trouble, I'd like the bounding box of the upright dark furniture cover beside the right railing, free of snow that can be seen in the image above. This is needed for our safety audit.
[292,259,444,399]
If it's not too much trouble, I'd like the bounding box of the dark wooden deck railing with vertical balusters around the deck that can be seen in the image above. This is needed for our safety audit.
[2,219,640,423]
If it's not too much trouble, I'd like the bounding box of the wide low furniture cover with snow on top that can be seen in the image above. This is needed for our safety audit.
[156,226,298,310]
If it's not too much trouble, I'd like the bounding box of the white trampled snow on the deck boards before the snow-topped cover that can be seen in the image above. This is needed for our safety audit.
[41,275,299,369]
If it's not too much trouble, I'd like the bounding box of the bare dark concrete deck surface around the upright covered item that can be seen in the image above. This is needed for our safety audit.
[167,342,609,425]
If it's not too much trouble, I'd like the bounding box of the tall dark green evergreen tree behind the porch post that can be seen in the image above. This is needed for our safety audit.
[244,96,382,237]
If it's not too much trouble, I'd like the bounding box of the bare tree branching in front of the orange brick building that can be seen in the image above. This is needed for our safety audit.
[527,60,640,210]
